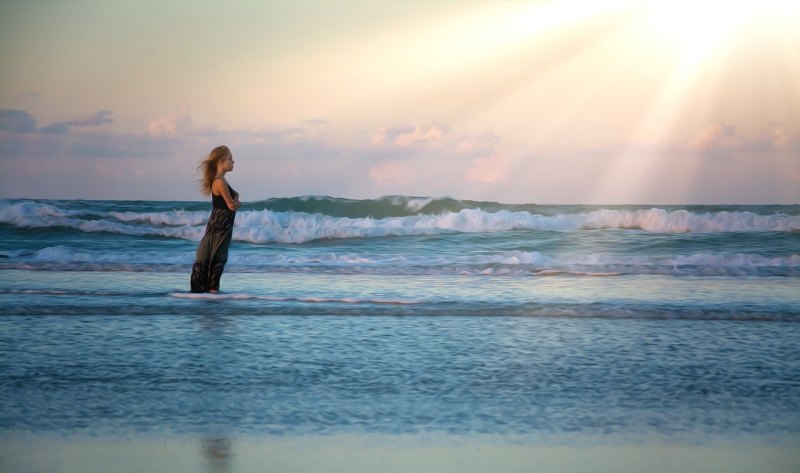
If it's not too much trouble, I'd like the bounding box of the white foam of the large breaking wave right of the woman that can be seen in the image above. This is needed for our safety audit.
[228,209,800,243]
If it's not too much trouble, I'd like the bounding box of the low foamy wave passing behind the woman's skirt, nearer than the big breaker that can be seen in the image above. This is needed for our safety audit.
[0,245,800,277]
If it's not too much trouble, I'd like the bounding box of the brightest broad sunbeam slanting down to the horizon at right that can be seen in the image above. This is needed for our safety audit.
[594,0,768,203]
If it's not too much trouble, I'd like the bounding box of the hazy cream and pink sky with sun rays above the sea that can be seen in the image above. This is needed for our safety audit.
[0,0,800,204]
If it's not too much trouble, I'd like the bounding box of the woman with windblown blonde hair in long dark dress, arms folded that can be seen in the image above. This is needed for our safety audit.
[191,146,241,293]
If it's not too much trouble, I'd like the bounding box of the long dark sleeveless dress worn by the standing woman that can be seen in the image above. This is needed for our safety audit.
[190,180,239,292]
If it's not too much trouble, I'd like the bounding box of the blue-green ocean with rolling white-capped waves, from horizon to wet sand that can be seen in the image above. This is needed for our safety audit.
[0,196,800,471]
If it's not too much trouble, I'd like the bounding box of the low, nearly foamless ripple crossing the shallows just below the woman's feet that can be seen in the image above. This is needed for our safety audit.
[0,289,800,323]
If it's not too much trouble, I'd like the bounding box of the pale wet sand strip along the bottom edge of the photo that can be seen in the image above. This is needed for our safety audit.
[0,434,800,473]
